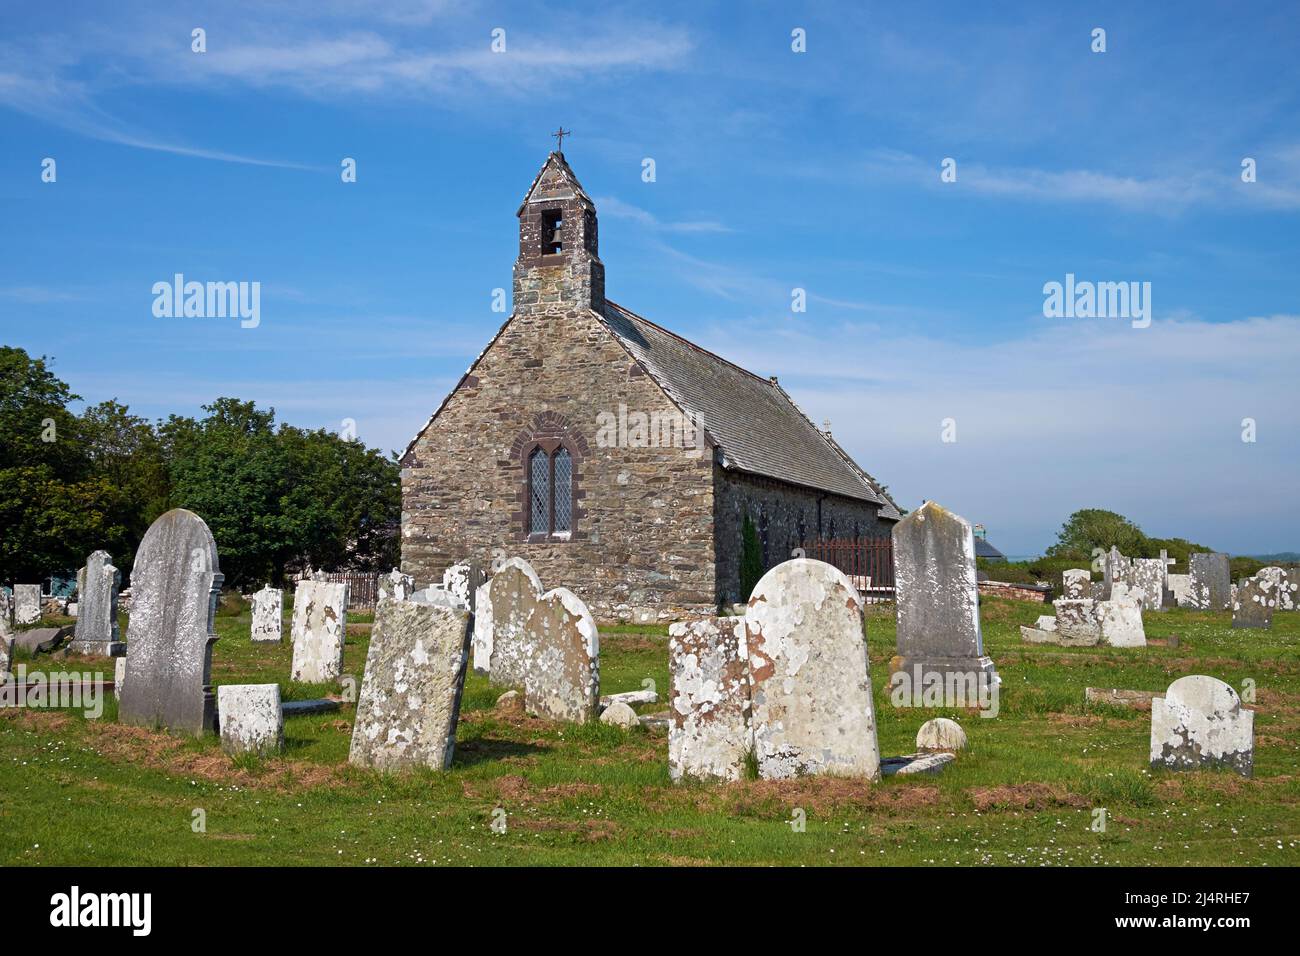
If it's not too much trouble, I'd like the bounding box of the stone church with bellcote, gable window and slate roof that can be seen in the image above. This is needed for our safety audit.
[402,152,901,620]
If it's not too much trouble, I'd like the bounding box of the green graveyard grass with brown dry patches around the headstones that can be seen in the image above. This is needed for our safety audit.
[0,598,1300,866]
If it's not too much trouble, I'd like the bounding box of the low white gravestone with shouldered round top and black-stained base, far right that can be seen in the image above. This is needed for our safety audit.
[1151,674,1255,777]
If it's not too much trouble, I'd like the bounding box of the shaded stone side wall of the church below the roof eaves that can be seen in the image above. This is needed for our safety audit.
[714,466,894,606]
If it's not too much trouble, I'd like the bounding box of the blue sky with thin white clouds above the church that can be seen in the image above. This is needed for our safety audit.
[0,0,1300,554]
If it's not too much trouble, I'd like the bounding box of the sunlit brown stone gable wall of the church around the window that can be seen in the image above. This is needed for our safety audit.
[402,306,715,619]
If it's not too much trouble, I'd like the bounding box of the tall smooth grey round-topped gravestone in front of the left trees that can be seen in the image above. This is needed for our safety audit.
[118,509,224,736]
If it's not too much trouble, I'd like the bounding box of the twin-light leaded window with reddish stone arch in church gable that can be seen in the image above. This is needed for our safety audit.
[510,412,590,541]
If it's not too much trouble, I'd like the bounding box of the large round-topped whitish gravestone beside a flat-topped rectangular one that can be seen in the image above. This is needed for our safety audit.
[745,556,878,780]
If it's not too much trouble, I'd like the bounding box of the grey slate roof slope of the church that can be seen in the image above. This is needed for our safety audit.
[597,299,901,520]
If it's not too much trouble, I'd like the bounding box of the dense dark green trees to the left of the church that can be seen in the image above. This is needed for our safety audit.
[0,347,402,587]
